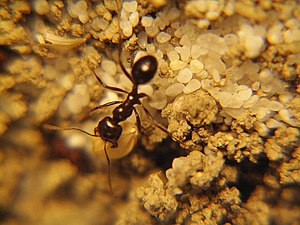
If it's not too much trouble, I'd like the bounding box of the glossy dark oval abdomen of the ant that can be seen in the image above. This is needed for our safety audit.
[131,55,158,84]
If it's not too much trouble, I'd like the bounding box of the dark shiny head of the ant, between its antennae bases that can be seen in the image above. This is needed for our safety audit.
[95,116,122,148]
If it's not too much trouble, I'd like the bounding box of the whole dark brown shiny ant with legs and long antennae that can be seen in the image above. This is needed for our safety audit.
[45,52,169,193]
